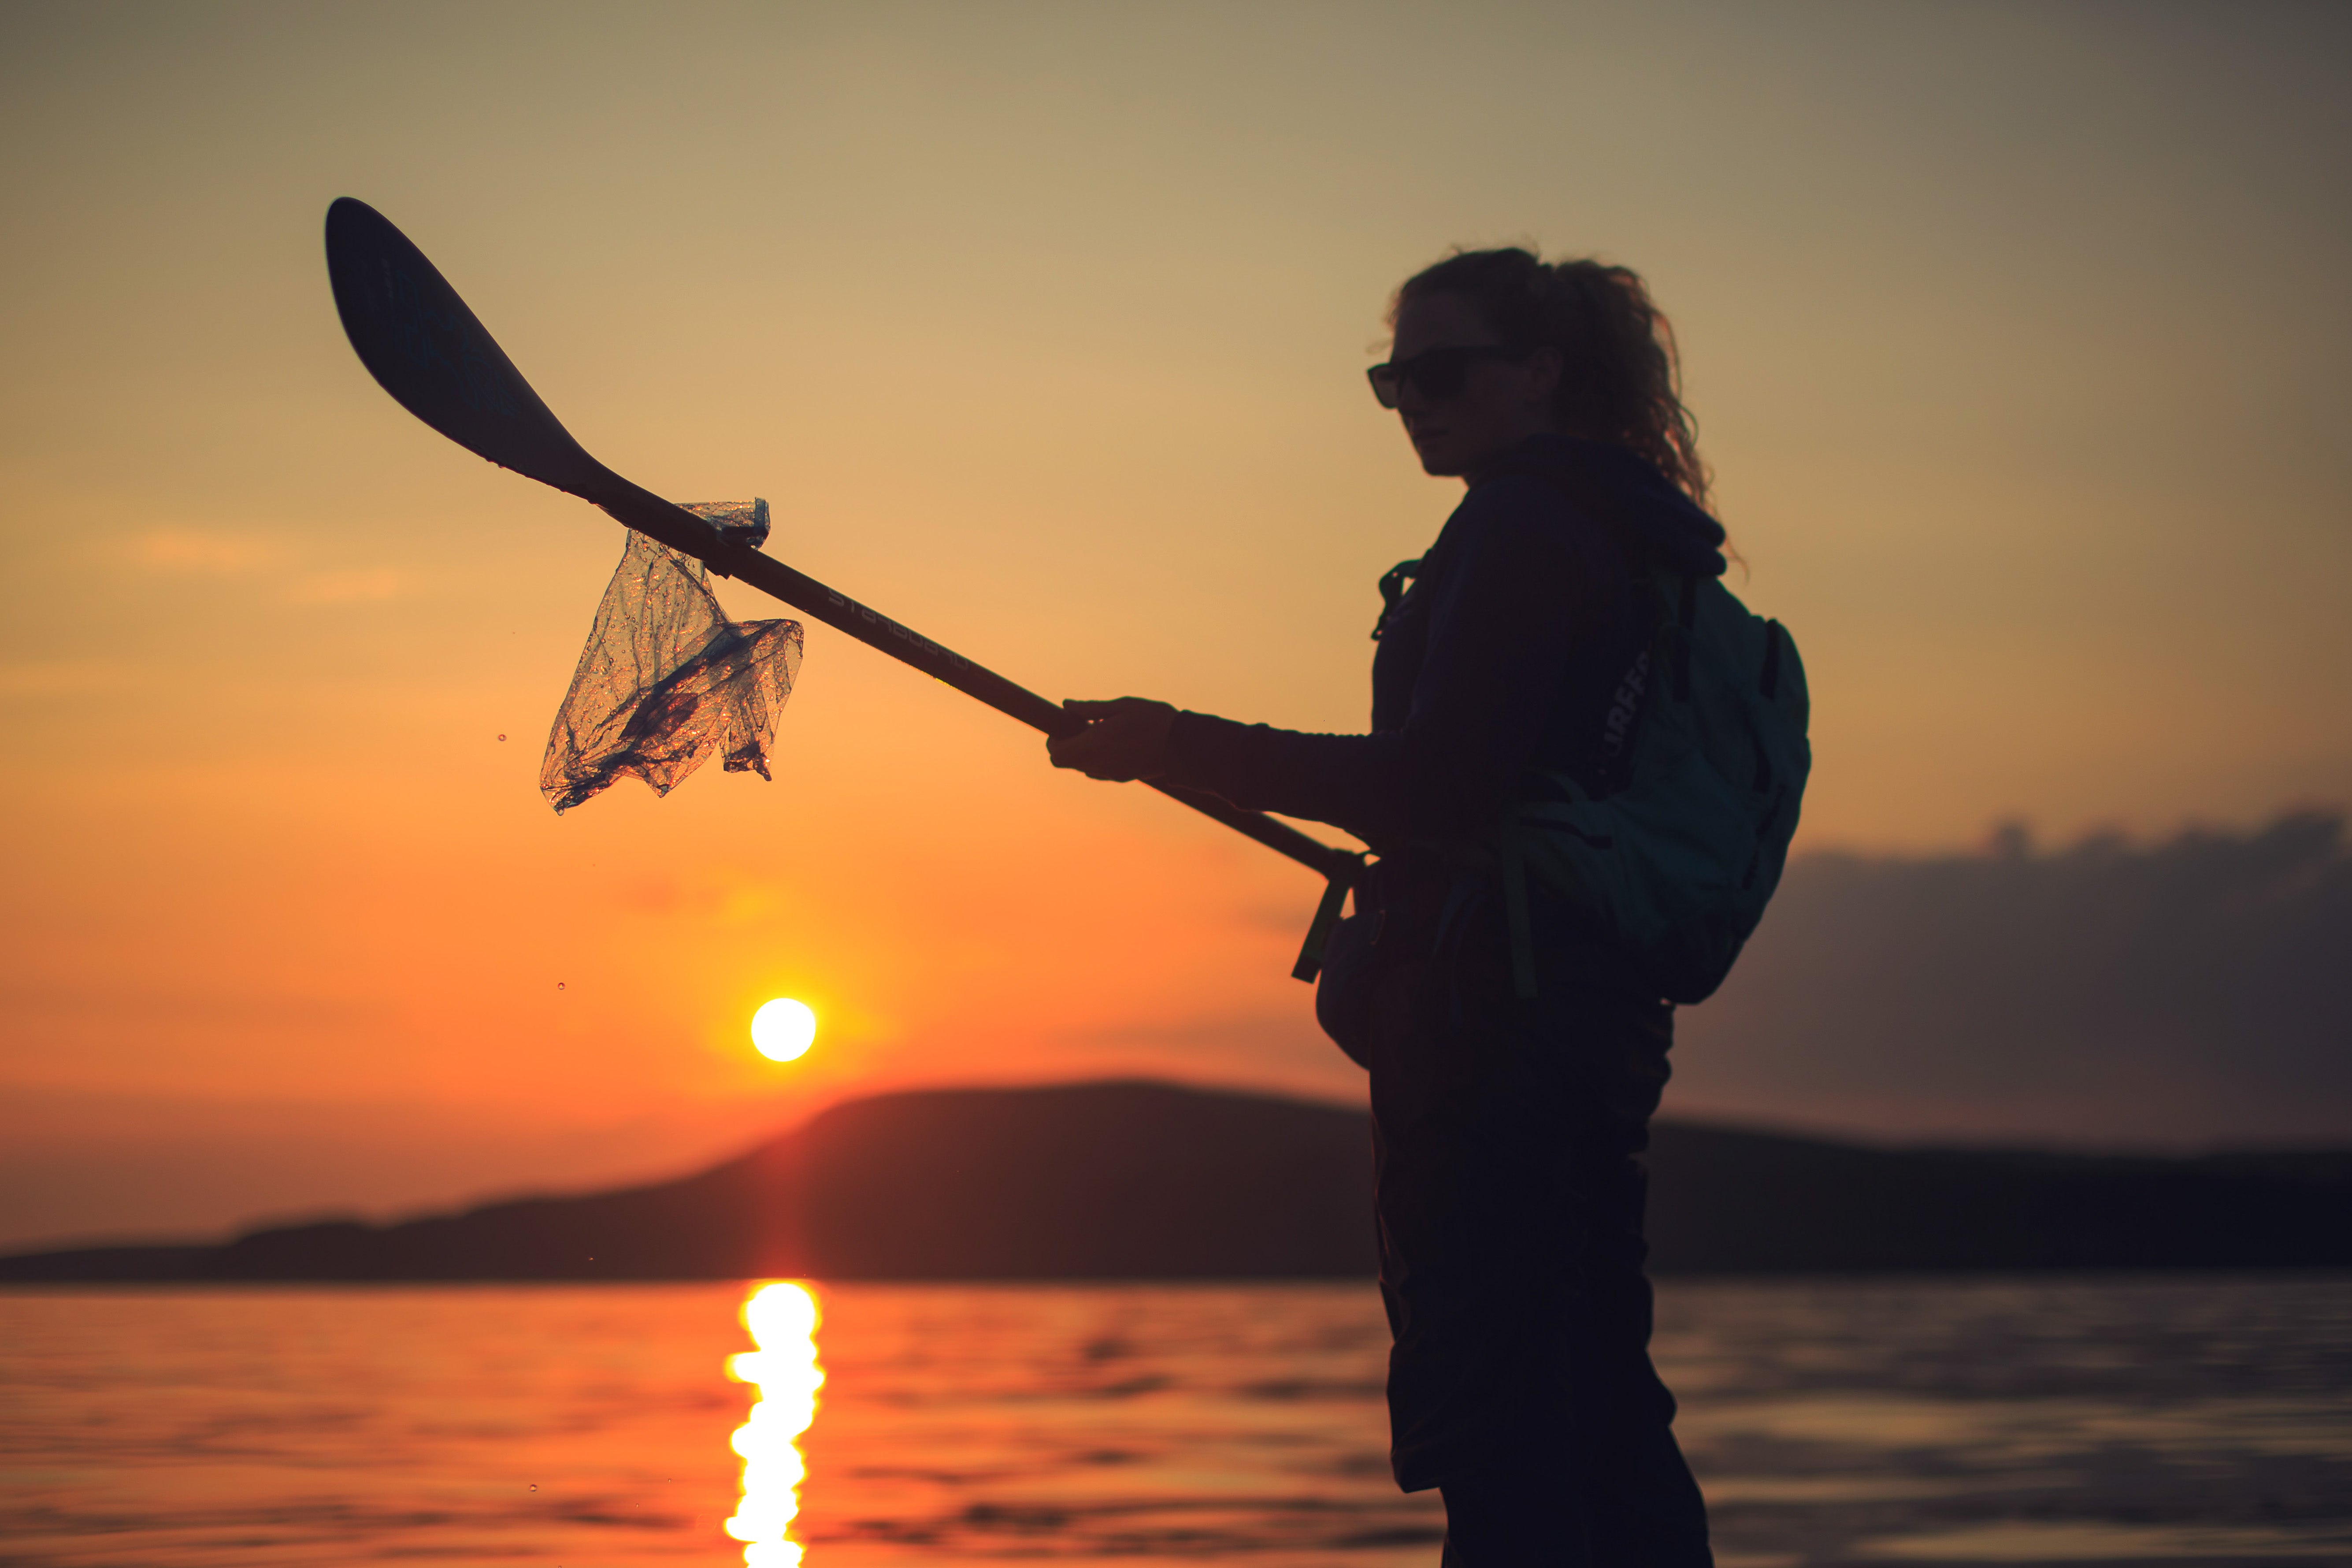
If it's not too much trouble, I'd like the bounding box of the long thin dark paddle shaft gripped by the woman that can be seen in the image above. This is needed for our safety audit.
[586,470,1364,893]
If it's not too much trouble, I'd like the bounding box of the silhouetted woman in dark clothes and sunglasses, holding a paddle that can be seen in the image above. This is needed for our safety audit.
[1051,249,1724,1568]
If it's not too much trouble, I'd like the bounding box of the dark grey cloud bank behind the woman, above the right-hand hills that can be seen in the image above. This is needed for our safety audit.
[1675,811,2352,1145]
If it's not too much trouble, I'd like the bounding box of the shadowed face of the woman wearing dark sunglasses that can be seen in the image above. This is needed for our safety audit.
[1387,294,1559,480]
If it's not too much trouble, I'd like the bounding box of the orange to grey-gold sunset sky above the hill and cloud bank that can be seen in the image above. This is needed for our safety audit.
[0,2,2352,1241]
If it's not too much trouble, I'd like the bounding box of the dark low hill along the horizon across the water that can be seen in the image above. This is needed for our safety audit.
[0,1084,2352,1283]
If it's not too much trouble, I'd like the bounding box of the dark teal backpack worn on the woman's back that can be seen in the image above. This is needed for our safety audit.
[1494,562,1814,1004]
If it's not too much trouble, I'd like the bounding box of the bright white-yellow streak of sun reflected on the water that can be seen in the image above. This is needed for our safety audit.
[727,1283,826,1568]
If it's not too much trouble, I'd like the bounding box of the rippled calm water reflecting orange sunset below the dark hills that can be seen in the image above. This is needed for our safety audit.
[0,1279,2352,1568]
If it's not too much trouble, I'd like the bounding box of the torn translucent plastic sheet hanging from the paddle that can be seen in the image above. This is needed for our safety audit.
[538,501,800,811]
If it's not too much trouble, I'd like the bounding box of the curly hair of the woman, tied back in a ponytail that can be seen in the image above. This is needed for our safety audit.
[1387,247,1710,505]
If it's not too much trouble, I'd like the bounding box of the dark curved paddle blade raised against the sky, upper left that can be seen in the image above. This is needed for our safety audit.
[327,195,612,501]
